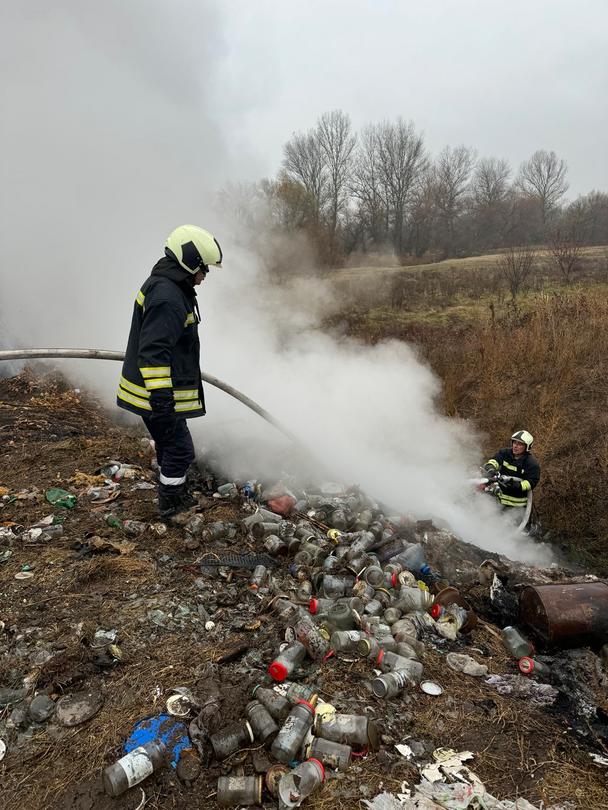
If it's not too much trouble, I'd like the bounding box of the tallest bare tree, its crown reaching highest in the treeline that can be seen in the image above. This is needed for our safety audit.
[316,110,356,239]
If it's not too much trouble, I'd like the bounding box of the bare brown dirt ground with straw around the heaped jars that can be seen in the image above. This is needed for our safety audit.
[0,371,608,810]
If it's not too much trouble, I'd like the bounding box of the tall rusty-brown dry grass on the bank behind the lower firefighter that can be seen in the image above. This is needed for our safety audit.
[338,284,608,572]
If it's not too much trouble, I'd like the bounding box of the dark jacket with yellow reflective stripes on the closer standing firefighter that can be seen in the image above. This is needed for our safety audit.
[117,257,205,418]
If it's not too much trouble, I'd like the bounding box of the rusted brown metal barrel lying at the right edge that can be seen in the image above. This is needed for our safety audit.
[519,582,608,647]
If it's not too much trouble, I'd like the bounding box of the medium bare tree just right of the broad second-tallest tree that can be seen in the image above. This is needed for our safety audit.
[435,146,475,256]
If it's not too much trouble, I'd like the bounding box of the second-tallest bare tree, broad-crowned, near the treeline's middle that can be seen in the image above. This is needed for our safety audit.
[376,118,428,255]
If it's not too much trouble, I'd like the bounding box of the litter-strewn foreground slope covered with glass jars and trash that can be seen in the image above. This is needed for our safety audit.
[0,370,608,810]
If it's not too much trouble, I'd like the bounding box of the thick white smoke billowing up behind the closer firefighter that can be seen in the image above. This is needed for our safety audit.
[0,0,547,561]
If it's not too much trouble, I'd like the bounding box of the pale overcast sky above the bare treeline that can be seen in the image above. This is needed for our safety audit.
[218,0,608,195]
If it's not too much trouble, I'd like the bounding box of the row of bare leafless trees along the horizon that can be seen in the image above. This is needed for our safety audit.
[225,110,608,266]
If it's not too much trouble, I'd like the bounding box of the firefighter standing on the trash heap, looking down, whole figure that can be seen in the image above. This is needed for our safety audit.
[117,225,222,518]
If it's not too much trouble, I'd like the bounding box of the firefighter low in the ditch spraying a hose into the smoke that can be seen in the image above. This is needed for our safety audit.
[484,430,540,507]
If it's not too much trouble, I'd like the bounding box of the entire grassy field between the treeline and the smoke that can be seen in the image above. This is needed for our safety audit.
[334,247,608,573]
